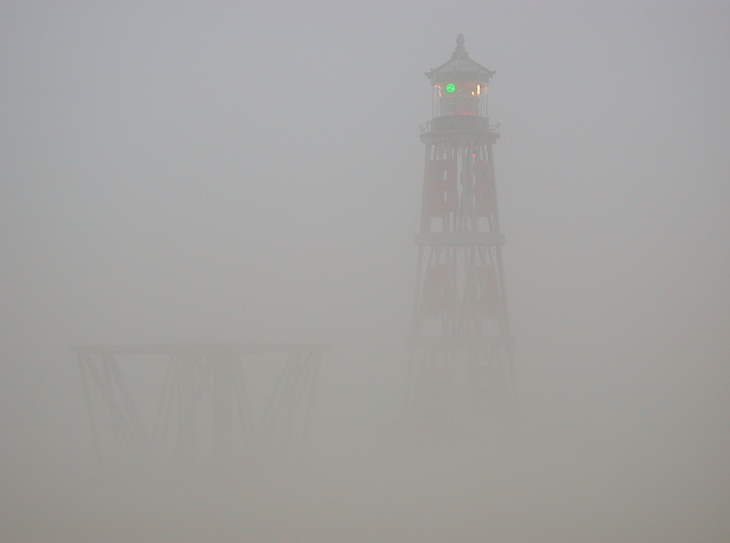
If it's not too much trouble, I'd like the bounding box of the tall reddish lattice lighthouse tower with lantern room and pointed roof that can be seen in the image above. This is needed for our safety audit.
[409,34,514,420]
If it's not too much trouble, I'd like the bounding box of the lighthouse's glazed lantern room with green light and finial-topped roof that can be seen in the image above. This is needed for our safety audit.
[426,34,496,130]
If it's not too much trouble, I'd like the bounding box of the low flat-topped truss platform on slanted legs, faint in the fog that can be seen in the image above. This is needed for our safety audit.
[70,343,327,474]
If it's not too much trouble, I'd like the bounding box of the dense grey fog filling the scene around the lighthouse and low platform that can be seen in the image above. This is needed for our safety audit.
[0,1,730,543]
